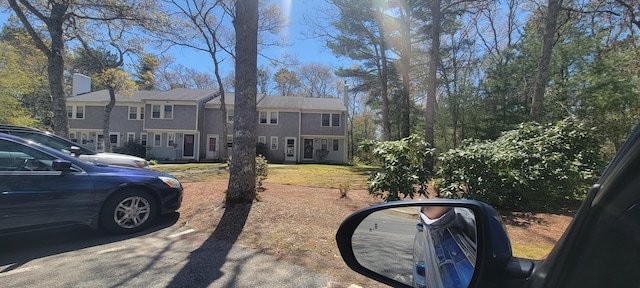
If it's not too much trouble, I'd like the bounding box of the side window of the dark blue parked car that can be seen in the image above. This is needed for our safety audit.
[0,140,54,171]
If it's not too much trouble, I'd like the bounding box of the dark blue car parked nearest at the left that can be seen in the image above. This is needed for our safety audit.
[0,133,182,234]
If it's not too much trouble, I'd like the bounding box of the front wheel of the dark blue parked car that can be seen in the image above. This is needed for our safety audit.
[100,190,158,234]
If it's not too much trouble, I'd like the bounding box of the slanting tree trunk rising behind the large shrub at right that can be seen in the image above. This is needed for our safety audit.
[529,0,562,122]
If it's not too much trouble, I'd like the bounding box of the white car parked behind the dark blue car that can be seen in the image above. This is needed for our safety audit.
[0,125,149,169]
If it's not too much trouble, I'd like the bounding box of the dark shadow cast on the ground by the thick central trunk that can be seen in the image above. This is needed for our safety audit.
[167,204,251,287]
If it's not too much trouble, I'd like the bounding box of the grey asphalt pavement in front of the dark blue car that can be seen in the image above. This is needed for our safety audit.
[0,215,358,288]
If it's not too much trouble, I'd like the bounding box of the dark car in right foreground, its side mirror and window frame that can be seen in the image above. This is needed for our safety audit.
[336,126,640,288]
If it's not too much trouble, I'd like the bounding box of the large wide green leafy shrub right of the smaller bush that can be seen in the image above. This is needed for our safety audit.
[438,118,603,209]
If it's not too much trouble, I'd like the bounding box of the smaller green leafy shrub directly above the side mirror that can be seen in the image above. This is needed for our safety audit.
[360,135,433,201]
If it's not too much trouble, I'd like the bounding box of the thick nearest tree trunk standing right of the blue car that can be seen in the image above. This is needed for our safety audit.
[226,0,258,206]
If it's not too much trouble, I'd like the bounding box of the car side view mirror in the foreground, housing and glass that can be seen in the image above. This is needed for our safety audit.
[336,199,534,288]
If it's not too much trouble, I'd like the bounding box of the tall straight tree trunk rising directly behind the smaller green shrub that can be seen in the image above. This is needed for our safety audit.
[424,0,442,171]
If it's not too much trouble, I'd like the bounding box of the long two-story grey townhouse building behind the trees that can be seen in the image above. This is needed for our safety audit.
[67,75,347,163]
